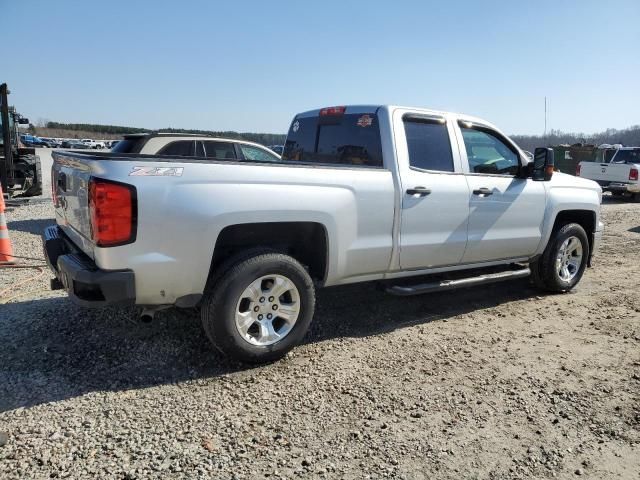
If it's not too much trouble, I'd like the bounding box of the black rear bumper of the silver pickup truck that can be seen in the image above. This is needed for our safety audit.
[43,226,136,307]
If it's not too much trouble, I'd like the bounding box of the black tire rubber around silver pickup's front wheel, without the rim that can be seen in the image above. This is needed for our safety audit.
[530,223,589,293]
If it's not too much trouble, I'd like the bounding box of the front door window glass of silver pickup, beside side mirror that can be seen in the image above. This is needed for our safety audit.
[460,125,520,175]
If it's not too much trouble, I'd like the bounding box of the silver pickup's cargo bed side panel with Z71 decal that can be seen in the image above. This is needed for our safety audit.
[53,152,395,304]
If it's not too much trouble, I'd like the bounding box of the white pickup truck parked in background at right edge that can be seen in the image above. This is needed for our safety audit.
[576,147,640,202]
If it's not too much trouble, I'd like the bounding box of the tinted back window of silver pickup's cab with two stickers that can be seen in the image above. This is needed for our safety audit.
[282,113,382,167]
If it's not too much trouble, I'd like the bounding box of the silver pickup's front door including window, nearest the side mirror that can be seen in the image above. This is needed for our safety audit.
[458,122,546,263]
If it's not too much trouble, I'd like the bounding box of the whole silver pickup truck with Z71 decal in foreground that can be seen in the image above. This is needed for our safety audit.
[44,106,603,362]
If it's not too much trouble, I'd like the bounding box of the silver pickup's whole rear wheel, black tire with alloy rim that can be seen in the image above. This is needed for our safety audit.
[201,252,315,363]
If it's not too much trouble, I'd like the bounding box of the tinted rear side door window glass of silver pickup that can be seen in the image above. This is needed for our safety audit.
[404,117,454,172]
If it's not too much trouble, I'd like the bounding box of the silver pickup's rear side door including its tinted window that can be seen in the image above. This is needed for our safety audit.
[394,110,469,270]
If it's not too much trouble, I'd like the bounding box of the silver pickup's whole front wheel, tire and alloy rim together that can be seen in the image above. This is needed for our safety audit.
[531,223,589,293]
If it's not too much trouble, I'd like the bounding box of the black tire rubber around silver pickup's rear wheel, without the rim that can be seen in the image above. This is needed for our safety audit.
[200,251,315,363]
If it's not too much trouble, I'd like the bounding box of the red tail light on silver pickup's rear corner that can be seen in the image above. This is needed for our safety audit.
[89,178,138,247]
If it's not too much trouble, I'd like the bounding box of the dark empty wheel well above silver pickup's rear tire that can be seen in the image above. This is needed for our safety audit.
[211,222,328,282]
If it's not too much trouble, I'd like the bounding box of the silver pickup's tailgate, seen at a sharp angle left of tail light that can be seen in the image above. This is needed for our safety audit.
[51,151,95,258]
